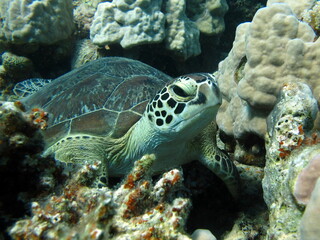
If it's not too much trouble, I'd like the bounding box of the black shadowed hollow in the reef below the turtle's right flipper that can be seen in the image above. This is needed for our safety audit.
[183,161,238,239]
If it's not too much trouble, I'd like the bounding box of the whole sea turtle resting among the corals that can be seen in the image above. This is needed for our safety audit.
[16,57,239,197]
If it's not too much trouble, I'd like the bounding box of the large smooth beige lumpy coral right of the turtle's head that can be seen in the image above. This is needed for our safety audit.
[217,3,320,144]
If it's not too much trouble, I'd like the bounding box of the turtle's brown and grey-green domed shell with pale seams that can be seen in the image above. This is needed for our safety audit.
[22,57,172,147]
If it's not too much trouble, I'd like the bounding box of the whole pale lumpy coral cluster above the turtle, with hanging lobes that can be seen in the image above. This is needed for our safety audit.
[90,0,228,59]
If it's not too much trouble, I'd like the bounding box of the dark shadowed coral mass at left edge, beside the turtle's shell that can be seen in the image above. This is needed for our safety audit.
[0,102,64,239]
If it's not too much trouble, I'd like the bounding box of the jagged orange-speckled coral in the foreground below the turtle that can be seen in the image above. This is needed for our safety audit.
[10,155,191,240]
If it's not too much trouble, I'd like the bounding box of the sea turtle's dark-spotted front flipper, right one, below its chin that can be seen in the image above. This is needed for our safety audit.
[197,122,240,199]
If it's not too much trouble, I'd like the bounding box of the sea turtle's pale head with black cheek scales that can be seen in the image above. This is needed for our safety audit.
[146,73,222,138]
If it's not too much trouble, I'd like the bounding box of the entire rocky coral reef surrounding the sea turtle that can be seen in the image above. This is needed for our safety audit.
[0,0,320,240]
